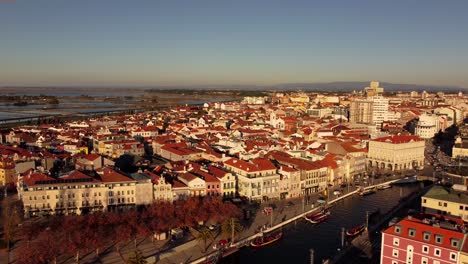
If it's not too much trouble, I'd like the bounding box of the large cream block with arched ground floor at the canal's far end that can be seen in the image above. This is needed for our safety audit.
[367,135,425,171]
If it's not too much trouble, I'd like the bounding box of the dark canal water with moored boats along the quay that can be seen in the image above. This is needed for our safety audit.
[221,184,421,264]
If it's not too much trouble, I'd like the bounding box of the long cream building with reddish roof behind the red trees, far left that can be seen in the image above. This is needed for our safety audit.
[18,168,146,217]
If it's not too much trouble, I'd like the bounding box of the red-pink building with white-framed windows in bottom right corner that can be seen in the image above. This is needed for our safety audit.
[380,217,465,264]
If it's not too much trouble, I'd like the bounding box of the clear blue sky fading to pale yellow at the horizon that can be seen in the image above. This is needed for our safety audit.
[0,0,468,87]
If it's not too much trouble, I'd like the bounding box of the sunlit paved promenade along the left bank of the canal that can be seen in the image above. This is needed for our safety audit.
[152,179,398,264]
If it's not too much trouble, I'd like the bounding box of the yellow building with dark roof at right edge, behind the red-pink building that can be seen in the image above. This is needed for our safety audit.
[421,185,468,221]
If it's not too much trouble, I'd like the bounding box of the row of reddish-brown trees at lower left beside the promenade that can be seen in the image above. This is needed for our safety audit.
[16,197,240,263]
